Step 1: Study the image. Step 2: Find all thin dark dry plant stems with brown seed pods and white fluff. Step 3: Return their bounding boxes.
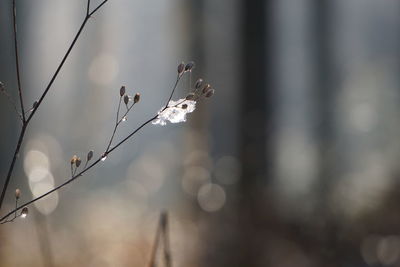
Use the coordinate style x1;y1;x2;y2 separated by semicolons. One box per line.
0;0;214;228
